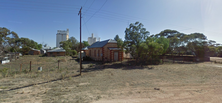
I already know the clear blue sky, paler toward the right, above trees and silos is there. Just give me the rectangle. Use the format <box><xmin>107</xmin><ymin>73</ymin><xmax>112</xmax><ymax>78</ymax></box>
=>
<box><xmin>0</xmin><ymin>0</ymin><xmax>222</xmax><ymax>47</ymax></box>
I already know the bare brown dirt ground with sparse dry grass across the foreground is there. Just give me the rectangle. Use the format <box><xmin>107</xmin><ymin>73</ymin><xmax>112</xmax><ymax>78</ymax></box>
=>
<box><xmin>0</xmin><ymin>56</ymin><xmax>222</xmax><ymax>103</ymax></box>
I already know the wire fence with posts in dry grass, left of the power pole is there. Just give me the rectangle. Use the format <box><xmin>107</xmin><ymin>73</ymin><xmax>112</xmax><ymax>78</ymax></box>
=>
<box><xmin>0</xmin><ymin>57</ymin><xmax>79</xmax><ymax>79</ymax></box>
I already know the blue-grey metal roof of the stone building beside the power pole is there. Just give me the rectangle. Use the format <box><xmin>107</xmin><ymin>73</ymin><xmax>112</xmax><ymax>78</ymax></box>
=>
<box><xmin>88</xmin><ymin>39</ymin><xmax>117</xmax><ymax>48</ymax></box>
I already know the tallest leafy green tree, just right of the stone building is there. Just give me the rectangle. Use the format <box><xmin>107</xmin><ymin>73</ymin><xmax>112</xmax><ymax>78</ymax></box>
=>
<box><xmin>125</xmin><ymin>22</ymin><xmax>150</xmax><ymax>59</ymax></box>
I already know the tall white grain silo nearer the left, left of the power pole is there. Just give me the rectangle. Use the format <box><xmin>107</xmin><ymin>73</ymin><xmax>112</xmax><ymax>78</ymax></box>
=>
<box><xmin>56</xmin><ymin>29</ymin><xmax>69</xmax><ymax>47</ymax></box>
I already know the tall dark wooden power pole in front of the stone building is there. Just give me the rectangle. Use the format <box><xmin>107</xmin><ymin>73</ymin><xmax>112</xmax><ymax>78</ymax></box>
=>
<box><xmin>78</xmin><ymin>7</ymin><xmax>82</xmax><ymax>75</ymax></box>
